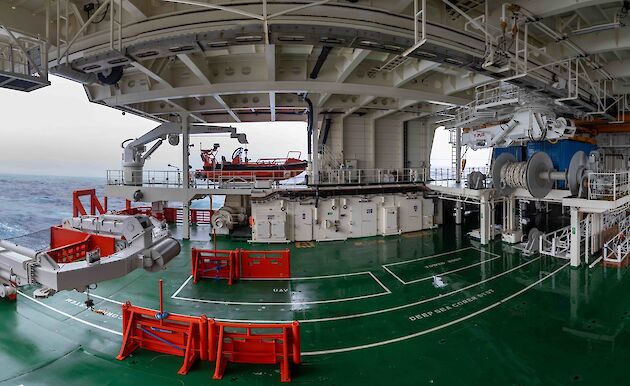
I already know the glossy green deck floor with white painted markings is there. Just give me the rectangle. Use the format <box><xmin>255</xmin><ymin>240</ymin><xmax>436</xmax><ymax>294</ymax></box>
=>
<box><xmin>0</xmin><ymin>226</ymin><xmax>630</xmax><ymax>386</ymax></box>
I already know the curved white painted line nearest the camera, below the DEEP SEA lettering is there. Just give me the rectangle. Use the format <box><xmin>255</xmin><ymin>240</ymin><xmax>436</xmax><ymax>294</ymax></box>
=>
<box><xmin>302</xmin><ymin>263</ymin><xmax>570</xmax><ymax>356</ymax></box>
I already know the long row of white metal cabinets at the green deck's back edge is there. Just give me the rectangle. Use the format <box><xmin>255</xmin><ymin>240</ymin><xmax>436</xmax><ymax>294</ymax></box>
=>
<box><xmin>252</xmin><ymin>193</ymin><xmax>441</xmax><ymax>243</ymax></box>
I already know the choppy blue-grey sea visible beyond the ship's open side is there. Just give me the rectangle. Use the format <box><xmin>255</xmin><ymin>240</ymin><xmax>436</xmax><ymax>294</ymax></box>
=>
<box><xmin>0</xmin><ymin>174</ymin><xmax>223</xmax><ymax>239</ymax></box>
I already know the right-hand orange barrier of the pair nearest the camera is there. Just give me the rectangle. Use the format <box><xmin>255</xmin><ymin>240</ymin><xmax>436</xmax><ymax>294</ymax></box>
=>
<box><xmin>208</xmin><ymin>321</ymin><xmax>301</xmax><ymax>382</ymax></box>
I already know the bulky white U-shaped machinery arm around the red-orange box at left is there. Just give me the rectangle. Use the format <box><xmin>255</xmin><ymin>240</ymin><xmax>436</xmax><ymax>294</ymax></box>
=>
<box><xmin>0</xmin><ymin>214</ymin><xmax>181</xmax><ymax>297</ymax></box>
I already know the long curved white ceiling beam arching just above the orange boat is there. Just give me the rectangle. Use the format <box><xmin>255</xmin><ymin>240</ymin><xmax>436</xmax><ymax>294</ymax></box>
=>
<box><xmin>97</xmin><ymin>81</ymin><xmax>469</xmax><ymax>105</ymax></box>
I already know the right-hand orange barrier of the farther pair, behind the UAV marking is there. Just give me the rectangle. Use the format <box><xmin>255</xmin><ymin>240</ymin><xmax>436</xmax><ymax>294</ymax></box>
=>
<box><xmin>239</xmin><ymin>249</ymin><xmax>291</xmax><ymax>279</ymax></box>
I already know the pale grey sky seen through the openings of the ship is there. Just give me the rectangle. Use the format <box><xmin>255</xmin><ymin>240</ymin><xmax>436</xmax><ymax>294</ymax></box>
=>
<box><xmin>0</xmin><ymin>76</ymin><xmax>488</xmax><ymax>177</ymax></box>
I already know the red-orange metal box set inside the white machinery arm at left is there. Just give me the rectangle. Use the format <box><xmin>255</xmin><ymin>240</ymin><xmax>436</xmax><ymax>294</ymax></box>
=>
<box><xmin>46</xmin><ymin>227</ymin><xmax>116</xmax><ymax>263</ymax></box>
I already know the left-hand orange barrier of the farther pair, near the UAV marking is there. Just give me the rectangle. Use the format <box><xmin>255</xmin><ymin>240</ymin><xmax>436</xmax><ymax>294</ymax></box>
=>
<box><xmin>192</xmin><ymin>248</ymin><xmax>239</xmax><ymax>285</ymax></box>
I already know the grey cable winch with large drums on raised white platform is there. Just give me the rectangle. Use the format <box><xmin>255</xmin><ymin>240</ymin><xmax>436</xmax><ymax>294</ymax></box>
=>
<box><xmin>492</xmin><ymin>151</ymin><xmax>588</xmax><ymax>198</ymax></box>
